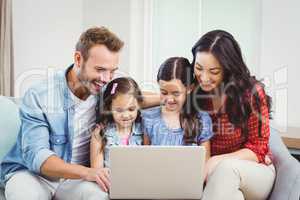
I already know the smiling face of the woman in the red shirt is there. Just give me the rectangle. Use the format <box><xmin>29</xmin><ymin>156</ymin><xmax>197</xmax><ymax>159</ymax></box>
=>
<box><xmin>194</xmin><ymin>52</ymin><xmax>223</xmax><ymax>92</ymax></box>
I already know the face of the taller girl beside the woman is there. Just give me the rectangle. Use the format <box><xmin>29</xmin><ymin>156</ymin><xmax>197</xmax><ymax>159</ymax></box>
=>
<box><xmin>158</xmin><ymin>79</ymin><xmax>187</xmax><ymax>112</ymax></box>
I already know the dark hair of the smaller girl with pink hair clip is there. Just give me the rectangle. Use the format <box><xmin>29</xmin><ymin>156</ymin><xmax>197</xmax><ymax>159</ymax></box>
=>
<box><xmin>96</xmin><ymin>77</ymin><xmax>143</xmax><ymax>150</ymax></box>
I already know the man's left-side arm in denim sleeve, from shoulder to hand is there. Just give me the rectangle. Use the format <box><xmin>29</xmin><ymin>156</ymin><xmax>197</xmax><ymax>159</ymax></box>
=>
<box><xmin>20</xmin><ymin>89</ymin><xmax>109</xmax><ymax>191</ymax></box>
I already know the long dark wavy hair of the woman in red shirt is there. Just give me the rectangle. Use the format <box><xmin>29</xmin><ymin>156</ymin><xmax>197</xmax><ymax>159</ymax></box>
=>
<box><xmin>192</xmin><ymin>30</ymin><xmax>271</xmax><ymax>136</ymax></box>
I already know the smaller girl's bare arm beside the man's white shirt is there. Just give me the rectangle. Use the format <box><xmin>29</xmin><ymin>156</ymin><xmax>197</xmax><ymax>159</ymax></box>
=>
<box><xmin>90</xmin><ymin>127</ymin><xmax>104</xmax><ymax>168</ymax></box>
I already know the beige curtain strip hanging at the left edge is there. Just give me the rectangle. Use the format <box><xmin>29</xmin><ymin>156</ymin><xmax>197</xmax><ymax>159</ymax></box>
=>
<box><xmin>0</xmin><ymin>0</ymin><xmax>14</xmax><ymax>96</ymax></box>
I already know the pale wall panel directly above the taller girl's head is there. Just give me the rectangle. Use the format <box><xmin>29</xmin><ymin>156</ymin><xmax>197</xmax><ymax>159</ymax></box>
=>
<box><xmin>152</xmin><ymin>0</ymin><xmax>201</xmax><ymax>80</ymax></box>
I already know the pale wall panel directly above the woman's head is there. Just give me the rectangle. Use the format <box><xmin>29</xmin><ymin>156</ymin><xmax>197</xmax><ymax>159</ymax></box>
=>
<box><xmin>202</xmin><ymin>0</ymin><xmax>261</xmax><ymax>75</ymax></box>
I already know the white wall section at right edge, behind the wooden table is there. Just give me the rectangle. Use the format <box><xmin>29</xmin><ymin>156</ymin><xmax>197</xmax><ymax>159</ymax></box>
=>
<box><xmin>260</xmin><ymin>0</ymin><xmax>300</xmax><ymax>129</ymax></box>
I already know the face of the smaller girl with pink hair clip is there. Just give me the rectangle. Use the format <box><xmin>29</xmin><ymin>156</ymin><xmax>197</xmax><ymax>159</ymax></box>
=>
<box><xmin>111</xmin><ymin>94</ymin><xmax>139</xmax><ymax>128</ymax></box>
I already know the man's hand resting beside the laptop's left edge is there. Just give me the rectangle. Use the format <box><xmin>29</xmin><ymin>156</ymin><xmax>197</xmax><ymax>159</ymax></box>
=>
<box><xmin>84</xmin><ymin>168</ymin><xmax>110</xmax><ymax>192</ymax></box>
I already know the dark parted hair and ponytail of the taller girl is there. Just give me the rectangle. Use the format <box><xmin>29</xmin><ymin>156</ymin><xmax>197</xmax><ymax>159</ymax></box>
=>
<box><xmin>157</xmin><ymin>57</ymin><xmax>202</xmax><ymax>144</ymax></box>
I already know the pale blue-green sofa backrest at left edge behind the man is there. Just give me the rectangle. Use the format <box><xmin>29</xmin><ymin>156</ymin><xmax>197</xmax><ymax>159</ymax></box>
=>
<box><xmin>0</xmin><ymin>96</ymin><xmax>21</xmax><ymax>162</ymax></box>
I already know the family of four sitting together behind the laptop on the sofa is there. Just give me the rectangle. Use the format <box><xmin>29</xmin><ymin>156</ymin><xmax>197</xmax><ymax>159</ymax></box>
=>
<box><xmin>0</xmin><ymin>27</ymin><xmax>276</xmax><ymax>200</ymax></box>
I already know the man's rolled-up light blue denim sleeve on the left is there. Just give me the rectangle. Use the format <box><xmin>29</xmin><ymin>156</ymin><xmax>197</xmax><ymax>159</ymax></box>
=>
<box><xmin>20</xmin><ymin>90</ymin><xmax>55</xmax><ymax>174</ymax></box>
